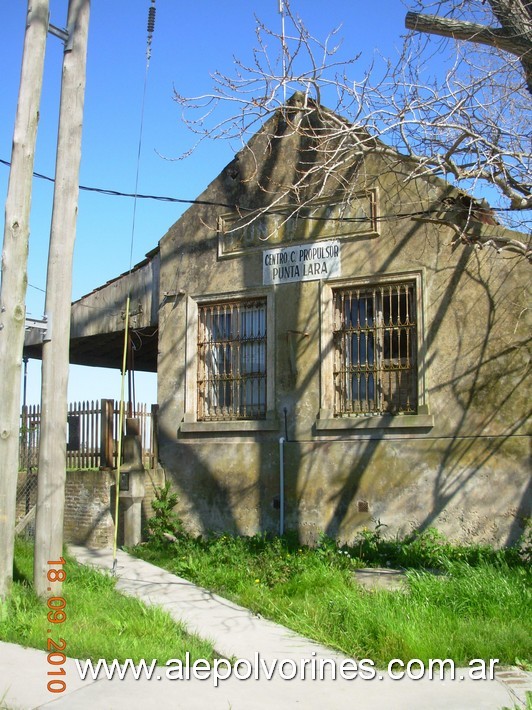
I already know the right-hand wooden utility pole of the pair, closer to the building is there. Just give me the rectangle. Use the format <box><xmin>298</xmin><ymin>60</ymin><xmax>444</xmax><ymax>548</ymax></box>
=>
<box><xmin>34</xmin><ymin>0</ymin><xmax>90</xmax><ymax>597</ymax></box>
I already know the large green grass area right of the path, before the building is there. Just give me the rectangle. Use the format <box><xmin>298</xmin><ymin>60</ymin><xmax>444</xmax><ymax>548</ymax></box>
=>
<box><xmin>130</xmin><ymin>531</ymin><xmax>532</xmax><ymax>667</ymax></box>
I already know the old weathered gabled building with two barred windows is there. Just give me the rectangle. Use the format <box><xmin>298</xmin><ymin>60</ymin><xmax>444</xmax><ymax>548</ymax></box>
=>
<box><xmin>26</xmin><ymin>96</ymin><xmax>531</xmax><ymax>544</ymax></box>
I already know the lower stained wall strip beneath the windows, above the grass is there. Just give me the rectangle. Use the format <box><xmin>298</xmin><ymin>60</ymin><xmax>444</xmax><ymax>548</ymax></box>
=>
<box><xmin>172</xmin><ymin>438</ymin><xmax>531</xmax><ymax>544</ymax></box>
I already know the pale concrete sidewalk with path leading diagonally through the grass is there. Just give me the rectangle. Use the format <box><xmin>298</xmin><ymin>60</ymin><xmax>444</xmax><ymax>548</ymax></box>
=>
<box><xmin>0</xmin><ymin>547</ymin><xmax>532</xmax><ymax>710</ymax></box>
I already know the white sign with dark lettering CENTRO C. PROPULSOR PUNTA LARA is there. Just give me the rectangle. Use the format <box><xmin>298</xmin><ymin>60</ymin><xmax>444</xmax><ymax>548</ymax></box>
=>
<box><xmin>262</xmin><ymin>239</ymin><xmax>341</xmax><ymax>286</ymax></box>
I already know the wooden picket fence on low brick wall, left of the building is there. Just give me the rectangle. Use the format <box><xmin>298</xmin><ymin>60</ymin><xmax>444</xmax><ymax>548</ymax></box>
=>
<box><xmin>19</xmin><ymin>399</ymin><xmax>157</xmax><ymax>470</ymax></box>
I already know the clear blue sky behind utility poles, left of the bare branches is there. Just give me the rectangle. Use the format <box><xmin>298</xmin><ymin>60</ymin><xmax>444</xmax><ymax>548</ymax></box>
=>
<box><xmin>0</xmin><ymin>0</ymin><xmax>407</xmax><ymax>403</ymax></box>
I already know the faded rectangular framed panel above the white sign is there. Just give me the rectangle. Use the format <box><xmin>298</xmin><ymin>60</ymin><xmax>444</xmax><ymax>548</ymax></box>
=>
<box><xmin>218</xmin><ymin>190</ymin><xmax>377</xmax><ymax>257</ymax></box>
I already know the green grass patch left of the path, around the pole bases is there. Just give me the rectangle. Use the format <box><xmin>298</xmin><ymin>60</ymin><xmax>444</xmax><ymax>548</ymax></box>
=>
<box><xmin>0</xmin><ymin>540</ymin><xmax>214</xmax><ymax>663</ymax></box>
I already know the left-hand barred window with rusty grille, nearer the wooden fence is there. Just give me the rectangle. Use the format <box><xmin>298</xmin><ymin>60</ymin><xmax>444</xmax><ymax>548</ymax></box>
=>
<box><xmin>198</xmin><ymin>299</ymin><xmax>266</xmax><ymax>421</ymax></box>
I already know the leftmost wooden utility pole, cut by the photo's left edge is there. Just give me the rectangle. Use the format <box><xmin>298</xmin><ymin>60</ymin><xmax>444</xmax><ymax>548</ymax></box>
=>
<box><xmin>0</xmin><ymin>0</ymin><xmax>49</xmax><ymax>601</ymax></box>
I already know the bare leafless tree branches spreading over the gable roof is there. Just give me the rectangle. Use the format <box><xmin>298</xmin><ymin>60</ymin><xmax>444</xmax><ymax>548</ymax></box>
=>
<box><xmin>175</xmin><ymin>0</ymin><xmax>532</xmax><ymax>259</ymax></box>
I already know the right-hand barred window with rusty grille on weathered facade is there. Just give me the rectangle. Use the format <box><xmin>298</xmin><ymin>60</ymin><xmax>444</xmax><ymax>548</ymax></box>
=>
<box><xmin>333</xmin><ymin>283</ymin><xmax>417</xmax><ymax>416</ymax></box>
